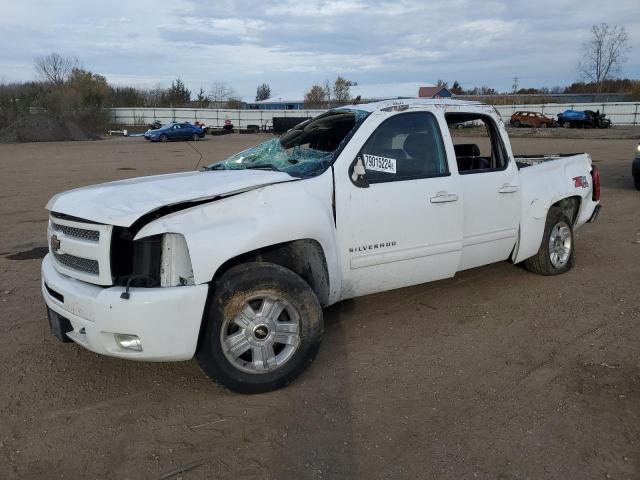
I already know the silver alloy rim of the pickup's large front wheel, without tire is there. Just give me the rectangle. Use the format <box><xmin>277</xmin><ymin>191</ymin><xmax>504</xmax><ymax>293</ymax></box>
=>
<box><xmin>220</xmin><ymin>294</ymin><xmax>300</xmax><ymax>374</ymax></box>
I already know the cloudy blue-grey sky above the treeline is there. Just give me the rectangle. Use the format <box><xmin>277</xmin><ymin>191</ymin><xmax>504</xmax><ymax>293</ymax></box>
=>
<box><xmin>0</xmin><ymin>0</ymin><xmax>640</xmax><ymax>100</ymax></box>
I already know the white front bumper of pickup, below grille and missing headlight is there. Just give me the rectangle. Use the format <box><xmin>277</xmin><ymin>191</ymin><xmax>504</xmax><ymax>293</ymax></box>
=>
<box><xmin>42</xmin><ymin>255</ymin><xmax>209</xmax><ymax>361</ymax></box>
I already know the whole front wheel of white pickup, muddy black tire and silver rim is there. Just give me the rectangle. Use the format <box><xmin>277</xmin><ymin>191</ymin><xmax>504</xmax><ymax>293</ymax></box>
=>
<box><xmin>196</xmin><ymin>262</ymin><xmax>323</xmax><ymax>393</ymax></box>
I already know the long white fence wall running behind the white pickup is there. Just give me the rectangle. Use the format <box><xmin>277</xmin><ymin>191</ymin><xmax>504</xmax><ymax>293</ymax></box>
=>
<box><xmin>110</xmin><ymin>102</ymin><xmax>640</xmax><ymax>128</ymax></box>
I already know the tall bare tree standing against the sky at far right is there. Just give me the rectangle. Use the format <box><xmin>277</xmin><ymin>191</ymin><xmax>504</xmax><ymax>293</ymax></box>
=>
<box><xmin>578</xmin><ymin>23</ymin><xmax>631</xmax><ymax>93</ymax></box>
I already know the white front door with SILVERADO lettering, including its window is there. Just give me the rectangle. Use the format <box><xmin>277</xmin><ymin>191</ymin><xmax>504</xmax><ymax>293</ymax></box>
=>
<box><xmin>335</xmin><ymin>111</ymin><xmax>463</xmax><ymax>298</ymax></box>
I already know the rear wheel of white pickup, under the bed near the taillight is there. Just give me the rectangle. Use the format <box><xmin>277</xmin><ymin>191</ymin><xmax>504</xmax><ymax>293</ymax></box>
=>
<box><xmin>524</xmin><ymin>207</ymin><xmax>575</xmax><ymax>275</ymax></box>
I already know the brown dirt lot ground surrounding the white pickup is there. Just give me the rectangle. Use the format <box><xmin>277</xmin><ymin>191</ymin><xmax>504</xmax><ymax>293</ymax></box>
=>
<box><xmin>0</xmin><ymin>135</ymin><xmax>640</xmax><ymax>480</ymax></box>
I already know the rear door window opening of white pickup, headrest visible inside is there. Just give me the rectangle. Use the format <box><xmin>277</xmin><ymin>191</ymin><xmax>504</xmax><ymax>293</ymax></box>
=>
<box><xmin>445</xmin><ymin>112</ymin><xmax>508</xmax><ymax>175</ymax></box>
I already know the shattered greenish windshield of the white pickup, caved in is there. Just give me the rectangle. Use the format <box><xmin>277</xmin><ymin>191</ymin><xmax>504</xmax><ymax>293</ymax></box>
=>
<box><xmin>205</xmin><ymin>108</ymin><xmax>368</xmax><ymax>177</ymax></box>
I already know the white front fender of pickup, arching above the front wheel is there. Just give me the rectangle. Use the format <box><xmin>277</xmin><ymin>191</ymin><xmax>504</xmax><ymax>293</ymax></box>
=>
<box><xmin>135</xmin><ymin>171</ymin><xmax>341</xmax><ymax>299</ymax></box>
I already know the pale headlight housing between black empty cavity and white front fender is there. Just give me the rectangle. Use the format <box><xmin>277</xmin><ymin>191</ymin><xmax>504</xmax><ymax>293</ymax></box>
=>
<box><xmin>160</xmin><ymin>233</ymin><xmax>195</xmax><ymax>287</ymax></box>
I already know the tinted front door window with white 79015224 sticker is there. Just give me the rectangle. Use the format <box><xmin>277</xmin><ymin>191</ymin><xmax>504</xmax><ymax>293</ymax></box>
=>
<box><xmin>357</xmin><ymin>112</ymin><xmax>449</xmax><ymax>184</ymax></box>
